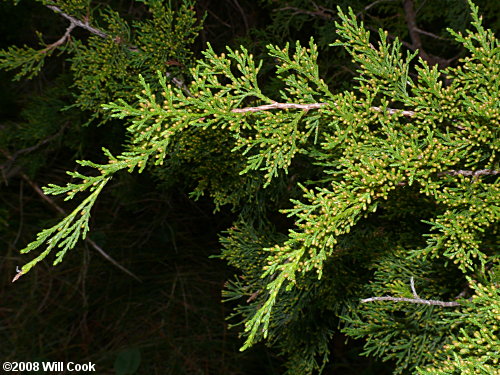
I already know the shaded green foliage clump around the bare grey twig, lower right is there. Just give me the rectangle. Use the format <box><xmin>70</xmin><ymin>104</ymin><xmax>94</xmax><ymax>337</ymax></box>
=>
<box><xmin>342</xmin><ymin>248</ymin><xmax>467</xmax><ymax>374</ymax></box>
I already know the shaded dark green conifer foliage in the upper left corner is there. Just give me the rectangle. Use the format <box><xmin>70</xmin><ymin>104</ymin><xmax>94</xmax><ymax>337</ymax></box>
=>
<box><xmin>0</xmin><ymin>0</ymin><xmax>201</xmax><ymax>120</ymax></box>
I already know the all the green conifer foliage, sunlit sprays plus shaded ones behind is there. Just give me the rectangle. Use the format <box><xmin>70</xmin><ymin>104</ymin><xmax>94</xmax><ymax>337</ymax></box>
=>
<box><xmin>0</xmin><ymin>1</ymin><xmax>500</xmax><ymax>374</ymax></box>
